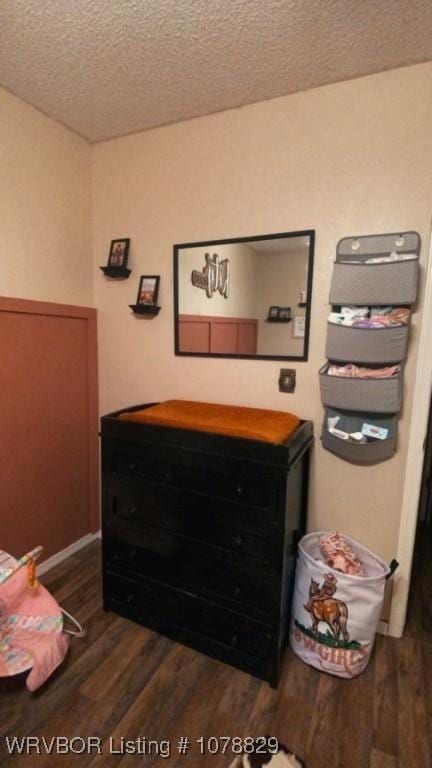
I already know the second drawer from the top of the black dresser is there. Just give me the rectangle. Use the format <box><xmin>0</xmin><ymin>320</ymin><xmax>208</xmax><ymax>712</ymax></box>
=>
<box><xmin>104</xmin><ymin>482</ymin><xmax>280</xmax><ymax>563</ymax></box>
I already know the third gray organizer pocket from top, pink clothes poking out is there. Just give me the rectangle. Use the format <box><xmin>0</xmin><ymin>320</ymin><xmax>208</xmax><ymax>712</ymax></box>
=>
<box><xmin>319</xmin><ymin>364</ymin><xmax>402</xmax><ymax>413</ymax></box>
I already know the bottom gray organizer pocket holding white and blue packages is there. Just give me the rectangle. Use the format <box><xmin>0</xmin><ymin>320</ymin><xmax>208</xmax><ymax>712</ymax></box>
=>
<box><xmin>321</xmin><ymin>408</ymin><xmax>396</xmax><ymax>464</ymax></box>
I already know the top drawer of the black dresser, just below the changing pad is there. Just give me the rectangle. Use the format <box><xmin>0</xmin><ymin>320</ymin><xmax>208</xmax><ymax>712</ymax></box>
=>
<box><xmin>104</xmin><ymin>442</ymin><xmax>274</xmax><ymax>509</ymax></box>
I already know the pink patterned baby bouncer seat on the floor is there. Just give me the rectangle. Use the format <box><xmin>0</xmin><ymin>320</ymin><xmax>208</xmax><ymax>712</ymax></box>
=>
<box><xmin>0</xmin><ymin>547</ymin><xmax>84</xmax><ymax>691</ymax></box>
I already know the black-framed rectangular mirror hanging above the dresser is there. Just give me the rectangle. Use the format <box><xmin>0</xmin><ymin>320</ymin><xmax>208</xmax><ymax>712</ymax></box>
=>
<box><xmin>174</xmin><ymin>229</ymin><xmax>315</xmax><ymax>360</ymax></box>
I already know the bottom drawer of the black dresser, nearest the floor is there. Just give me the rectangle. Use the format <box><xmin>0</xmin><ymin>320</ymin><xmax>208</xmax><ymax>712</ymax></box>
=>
<box><xmin>104</xmin><ymin>570</ymin><xmax>272</xmax><ymax>660</ymax></box>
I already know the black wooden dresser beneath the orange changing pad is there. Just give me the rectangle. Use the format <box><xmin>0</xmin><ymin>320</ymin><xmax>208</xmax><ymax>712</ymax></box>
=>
<box><xmin>101</xmin><ymin>403</ymin><xmax>313</xmax><ymax>687</ymax></box>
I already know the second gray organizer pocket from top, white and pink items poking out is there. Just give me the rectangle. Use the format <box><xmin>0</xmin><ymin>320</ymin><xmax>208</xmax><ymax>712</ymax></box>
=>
<box><xmin>325</xmin><ymin>323</ymin><xmax>408</xmax><ymax>364</ymax></box>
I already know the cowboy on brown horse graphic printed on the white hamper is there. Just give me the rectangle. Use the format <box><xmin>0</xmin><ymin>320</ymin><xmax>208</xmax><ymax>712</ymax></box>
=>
<box><xmin>303</xmin><ymin>573</ymin><xmax>349</xmax><ymax>643</ymax></box>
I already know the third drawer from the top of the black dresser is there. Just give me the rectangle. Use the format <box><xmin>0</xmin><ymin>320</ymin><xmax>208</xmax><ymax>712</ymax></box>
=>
<box><xmin>103</xmin><ymin>535</ymin><xmax>281</xmax><ymax>621</ymax></box>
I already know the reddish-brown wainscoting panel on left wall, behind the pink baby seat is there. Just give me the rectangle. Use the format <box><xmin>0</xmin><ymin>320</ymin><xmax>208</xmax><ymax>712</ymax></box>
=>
<box><xmin>0</xmin><ymin>297</ymin><xmax>99</xmax><ymax>559</ymax></box>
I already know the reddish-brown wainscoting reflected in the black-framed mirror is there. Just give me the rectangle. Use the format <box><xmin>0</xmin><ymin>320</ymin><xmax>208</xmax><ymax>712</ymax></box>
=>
<box><xmin>179</xmin><ymin>315</ymin><xmax>258</xmax><ymax>355</ymax></box>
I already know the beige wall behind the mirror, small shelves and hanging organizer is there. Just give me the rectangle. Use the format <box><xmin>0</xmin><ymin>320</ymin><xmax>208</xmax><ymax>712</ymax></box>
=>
<box><xmin>93</xmin><ymin>64</ymin><xmax>432</xmax><ymax>558</ymax></box>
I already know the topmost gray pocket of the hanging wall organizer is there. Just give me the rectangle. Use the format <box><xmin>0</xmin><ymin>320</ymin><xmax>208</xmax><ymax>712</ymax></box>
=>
<box><xmin>330</xmin><ymin>258</ymin><xmax>418</xmax><ymax>306</ymax></box>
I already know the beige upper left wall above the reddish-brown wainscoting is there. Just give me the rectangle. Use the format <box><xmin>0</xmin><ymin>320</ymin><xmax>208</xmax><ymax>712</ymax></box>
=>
<box><xmin>0</xmin><ymin>89</ymin><xmax>92</xmax><ymax>305</ymax></box>
